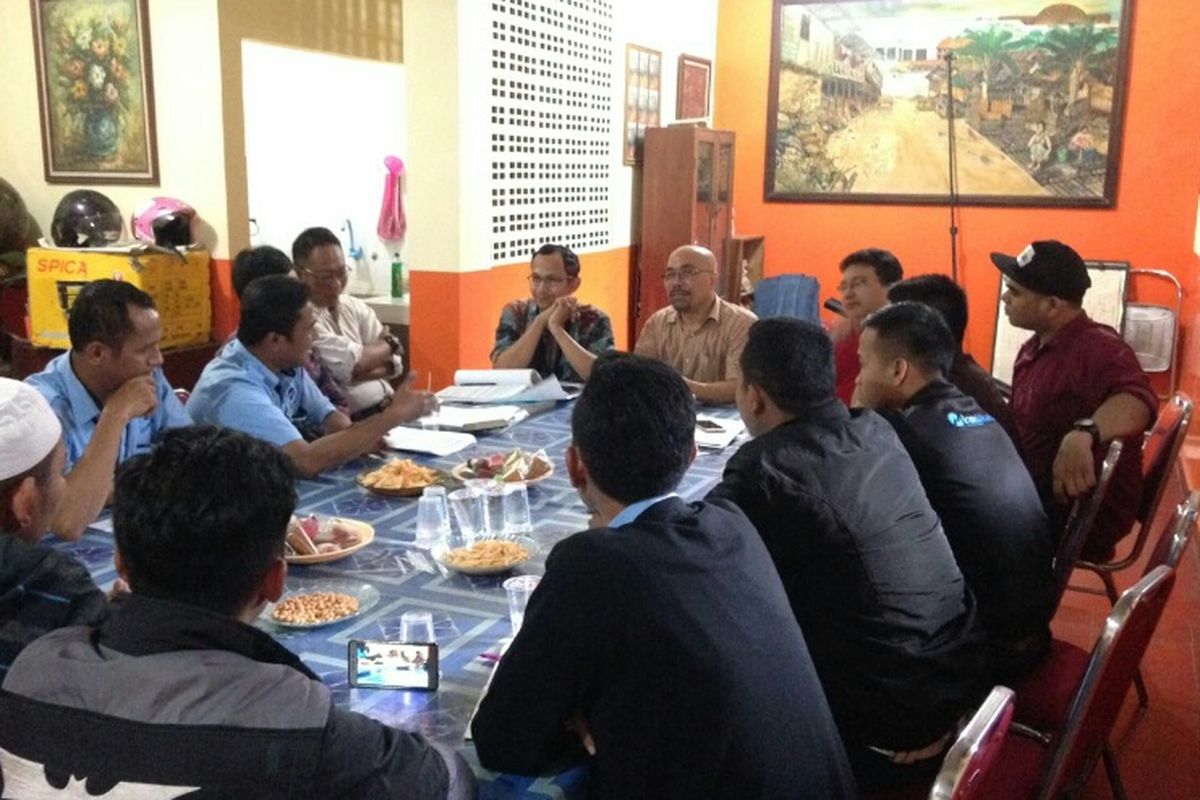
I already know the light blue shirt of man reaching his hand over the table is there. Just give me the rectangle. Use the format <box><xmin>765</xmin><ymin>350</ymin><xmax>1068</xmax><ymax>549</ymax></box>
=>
<box><xmin>187</xmin><ymin>339</ymin><xmax>336</xmax><ymax>447</ymax></box>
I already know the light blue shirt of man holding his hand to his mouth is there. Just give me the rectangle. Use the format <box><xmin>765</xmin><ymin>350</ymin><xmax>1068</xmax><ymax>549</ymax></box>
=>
<box><xmin>25</xmin><ymin>350</ymin><xmax>192</xmax><ymax>470</ymax></box>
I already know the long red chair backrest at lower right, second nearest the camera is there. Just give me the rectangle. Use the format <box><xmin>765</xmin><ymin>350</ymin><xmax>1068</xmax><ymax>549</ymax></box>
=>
<box><xmin>1038</xmin><ymin>566</ymin><xmax>1175</xmax><ymax>800</ymax></box>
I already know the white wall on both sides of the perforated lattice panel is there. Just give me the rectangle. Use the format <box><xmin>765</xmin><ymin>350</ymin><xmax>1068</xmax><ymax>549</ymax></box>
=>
<box><xmin>404</xmin><ymin>0</ymin><xmax>716</xmax><ymax>272</ymax></box>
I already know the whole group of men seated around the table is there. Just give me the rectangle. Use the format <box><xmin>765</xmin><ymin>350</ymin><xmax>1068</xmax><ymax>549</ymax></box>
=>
<box><xmin>0</xmin><ymin>229</ymin><xmax>1157</xmax><ymax>798</ymax></box>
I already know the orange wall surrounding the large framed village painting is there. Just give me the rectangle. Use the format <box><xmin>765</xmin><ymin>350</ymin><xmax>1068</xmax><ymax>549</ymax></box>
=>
<box><xmin>714</xmin><ymin>0</ymin><xmax>1200</xmax><ymax>389</ymax></box>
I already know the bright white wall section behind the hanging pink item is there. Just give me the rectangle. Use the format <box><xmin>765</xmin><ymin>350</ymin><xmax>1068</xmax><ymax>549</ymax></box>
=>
<box><xmin>241</xmin><ymin>41</ymin><xmax>406</xmax><ymax>294</ymax></box>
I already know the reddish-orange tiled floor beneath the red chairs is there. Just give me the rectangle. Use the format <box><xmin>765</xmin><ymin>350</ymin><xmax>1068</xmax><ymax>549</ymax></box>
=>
<box><xmin>1054</xmin><ymin>472</ymin><xmax>1200</xmax><ymax>800</ymax></box>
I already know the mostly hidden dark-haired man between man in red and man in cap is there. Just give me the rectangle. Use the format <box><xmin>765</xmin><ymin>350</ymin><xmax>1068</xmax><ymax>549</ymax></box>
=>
<box><xmin>888</xmin><ymin>275</ymin><xmax>1018</xmax><ymax>443</ymax></box>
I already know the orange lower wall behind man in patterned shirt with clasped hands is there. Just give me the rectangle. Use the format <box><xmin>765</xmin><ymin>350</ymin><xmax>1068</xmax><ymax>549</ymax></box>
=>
<box><xmin>409</xmin><ymin>247</ymin><xmax>631</xmax><ymax>387</ymax></box>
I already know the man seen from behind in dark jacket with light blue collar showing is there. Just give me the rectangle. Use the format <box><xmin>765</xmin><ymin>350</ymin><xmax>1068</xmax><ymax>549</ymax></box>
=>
<box><xmin>473</xmin><ymin>355</ymin><xmax>856</xmax><ymax>800</ymax></box>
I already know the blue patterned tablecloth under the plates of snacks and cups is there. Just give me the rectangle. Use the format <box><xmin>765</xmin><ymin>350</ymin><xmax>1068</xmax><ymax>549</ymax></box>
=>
<box><xmin>61</xmin><ymin>403</ymin><xmax>745</xmax><ymax>798</ymax></box>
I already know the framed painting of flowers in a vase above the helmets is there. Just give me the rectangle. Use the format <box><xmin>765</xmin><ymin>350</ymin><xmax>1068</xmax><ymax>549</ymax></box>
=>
<box><xmin>30</xmin><ymin>0</ymin><xmax>158</xmax><ymax>185</ymax></box>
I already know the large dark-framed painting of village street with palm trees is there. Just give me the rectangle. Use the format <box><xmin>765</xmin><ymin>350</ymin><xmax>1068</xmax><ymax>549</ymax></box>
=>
<box><xmin>764</xmin><ymin>0</ymin><xmax>1134</xmax><ymax>207</ymax></box>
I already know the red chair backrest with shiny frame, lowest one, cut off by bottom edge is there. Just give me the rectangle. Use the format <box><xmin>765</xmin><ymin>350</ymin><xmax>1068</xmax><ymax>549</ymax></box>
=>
<box><xmin>929</xmin><ymin>686</ymin><xmax>1013</xmax><ymax>800</ymax></box>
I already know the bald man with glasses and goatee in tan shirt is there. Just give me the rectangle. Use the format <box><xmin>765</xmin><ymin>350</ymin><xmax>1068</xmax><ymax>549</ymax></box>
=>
<box><xmin>634</xmin><ymin>245</ymin><xmax>757</xmax><ymax>403</ymax></box>
